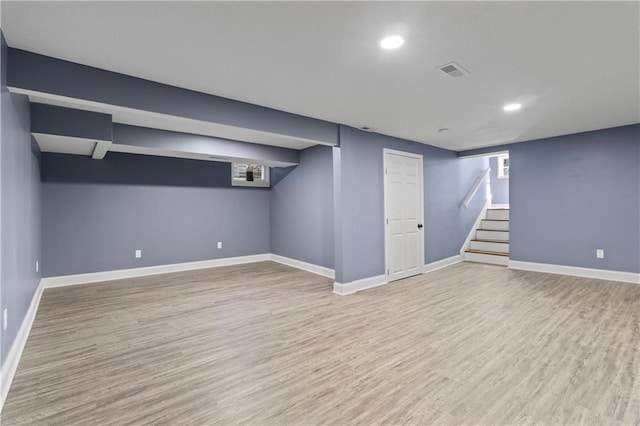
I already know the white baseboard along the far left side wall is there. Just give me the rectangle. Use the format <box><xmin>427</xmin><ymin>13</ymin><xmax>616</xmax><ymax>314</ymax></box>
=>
<box><xmin>0</xmin><ymin>280</ymin><xmax>44</xmax><ymax>412</ymax></box>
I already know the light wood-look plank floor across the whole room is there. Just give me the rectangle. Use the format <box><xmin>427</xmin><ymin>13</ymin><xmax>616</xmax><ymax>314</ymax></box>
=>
<box><xmin>2</xmin><ymin>262</ymin><xmax>640</xmax><ymax>425</ymax></box>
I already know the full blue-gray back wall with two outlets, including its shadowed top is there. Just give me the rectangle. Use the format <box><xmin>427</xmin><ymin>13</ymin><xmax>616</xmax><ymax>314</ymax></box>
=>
<box><xmin>42</xmin><ymin>153</ymin><xmax>270</xmax><ymax>277</ymax></box>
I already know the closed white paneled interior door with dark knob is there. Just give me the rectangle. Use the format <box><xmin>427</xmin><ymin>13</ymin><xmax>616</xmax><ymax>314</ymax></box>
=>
<box><xmin>384</xmin><ymin>149</ymin><xmax>424</xmax><ymax>281</ymax></box>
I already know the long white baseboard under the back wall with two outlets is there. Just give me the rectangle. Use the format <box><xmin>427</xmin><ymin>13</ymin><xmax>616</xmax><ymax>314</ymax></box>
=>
<box><xmin>42</xmin><ymin>253</ymin><xmax>271</xmax><ymax>288</ymax></box>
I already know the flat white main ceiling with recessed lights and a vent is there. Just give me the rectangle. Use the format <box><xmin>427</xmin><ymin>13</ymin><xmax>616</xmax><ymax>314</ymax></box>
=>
<box><xmin>2</xmin><ymin>1</ymin><xmax>640</xmax><ymax>150</ymax></box>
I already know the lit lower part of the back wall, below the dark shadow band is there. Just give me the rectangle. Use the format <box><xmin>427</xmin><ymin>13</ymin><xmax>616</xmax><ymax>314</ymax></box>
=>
<box><xmin>43</xmin><ymin>182</ymin><xmax>270</xmax><ymax>277</ymax></box>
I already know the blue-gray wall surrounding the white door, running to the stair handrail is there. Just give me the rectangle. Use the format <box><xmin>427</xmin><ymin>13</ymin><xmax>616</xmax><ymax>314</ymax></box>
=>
<box><xmin>334</xmin><ymin>126</ymin><xmax>488</xmax><ymax>283</ymax></box>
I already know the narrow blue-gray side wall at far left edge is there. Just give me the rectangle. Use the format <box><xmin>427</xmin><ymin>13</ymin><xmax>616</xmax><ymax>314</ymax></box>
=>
<box><xmin>0</xmin><ymin>33</ymin><xmax>41</xmax><ymax>364</ymax></box>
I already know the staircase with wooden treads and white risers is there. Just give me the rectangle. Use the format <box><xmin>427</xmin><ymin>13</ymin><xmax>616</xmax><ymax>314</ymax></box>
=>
<box><xmin>464</xmin><ymin>208</ymin><xmax>509</xmax><ymax>266</ymax></box>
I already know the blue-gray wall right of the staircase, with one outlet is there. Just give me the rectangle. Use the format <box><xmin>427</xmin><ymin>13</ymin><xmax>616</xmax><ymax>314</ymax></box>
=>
<box><xmin>508</xmin><ymin>125</ymin><xmax>640</xmax><ymax>272</ymax></box>
